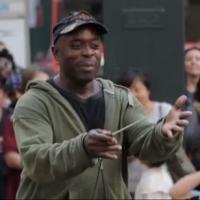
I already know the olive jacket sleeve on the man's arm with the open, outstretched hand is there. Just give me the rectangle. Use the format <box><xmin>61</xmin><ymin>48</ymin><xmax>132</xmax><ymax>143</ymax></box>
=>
<box><xmin>124</xmin><ymin>91</ymin><xmax>182</xmax><ymax>162</ymax></box>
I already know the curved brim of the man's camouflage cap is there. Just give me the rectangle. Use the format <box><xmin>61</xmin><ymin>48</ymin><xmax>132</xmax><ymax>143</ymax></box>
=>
<box><xmin>59</xmin><ymin>22</ymin><xmax>108</xmax><ymax>35</ymax></box>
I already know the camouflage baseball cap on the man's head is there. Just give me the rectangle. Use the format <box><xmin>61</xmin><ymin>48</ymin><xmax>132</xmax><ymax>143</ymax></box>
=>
<box><xmin>53</xmin><ymin>10</ymin><xmax>108</xmax><ymax>44</ymax></box>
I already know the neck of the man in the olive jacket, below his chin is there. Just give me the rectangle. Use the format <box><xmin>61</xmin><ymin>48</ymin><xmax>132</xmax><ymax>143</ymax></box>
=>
<box><xmin>54</xmin><ymin>75</ymin><xmax>101</xmax><ymax>99</ymax></box>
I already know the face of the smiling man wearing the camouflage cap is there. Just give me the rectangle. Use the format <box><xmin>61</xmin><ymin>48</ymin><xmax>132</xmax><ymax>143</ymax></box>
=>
<box><xmin>53</xmin><ymin>27</ymin><xmax>103</xmax><ymax>83</ymax></box>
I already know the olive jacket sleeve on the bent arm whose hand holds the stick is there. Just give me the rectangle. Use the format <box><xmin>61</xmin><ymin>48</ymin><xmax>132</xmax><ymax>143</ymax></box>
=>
<box><xmin>14</xmin><ymin>94</ymin><xmax>94</xmax><ymax>183</ymax></box>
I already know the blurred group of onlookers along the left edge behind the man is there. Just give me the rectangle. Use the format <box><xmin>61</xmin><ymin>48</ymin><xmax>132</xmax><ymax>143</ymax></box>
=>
<box><xmin>0</xmin><ymin>42</ymin><xmax>54</xmax><ymax>199</ymax></box>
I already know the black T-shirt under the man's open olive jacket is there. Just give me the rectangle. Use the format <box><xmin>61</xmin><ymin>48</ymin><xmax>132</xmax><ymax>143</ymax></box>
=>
<box><xmin>47</xmin><ymin>79</ymin><xmax>105</xmax><ymax>130</ymax></box>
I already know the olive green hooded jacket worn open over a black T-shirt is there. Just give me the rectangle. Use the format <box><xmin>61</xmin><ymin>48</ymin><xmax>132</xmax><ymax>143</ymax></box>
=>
<box><xmin>14</xmin><ymin>79</ymin><xmax>182</xmax><ymax>199</ymax></box>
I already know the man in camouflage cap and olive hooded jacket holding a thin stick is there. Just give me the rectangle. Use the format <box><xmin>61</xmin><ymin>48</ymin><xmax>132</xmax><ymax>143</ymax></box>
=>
<box><xmin>14</xmin><ymin>11</ymin><xmax>191</xmax><ymax>199</ymax></box>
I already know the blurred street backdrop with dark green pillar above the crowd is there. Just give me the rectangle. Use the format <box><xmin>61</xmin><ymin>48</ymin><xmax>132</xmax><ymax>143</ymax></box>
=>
<box><xmin>0</xmin><ymin>0</ymin><xmax>200</xmax><ymax>102</ymax></box>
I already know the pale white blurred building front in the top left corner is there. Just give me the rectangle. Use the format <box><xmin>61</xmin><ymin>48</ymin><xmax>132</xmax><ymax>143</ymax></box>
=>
<box><xmin>0</xmin><ymin>0</ymin><xmax>30</xmax><ymax>68</ymax></box>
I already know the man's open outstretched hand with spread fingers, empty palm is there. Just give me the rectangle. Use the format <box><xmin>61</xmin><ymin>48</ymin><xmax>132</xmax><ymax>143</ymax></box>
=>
<box><xmin>162</xmin><ymin>95</ymin><xmax>192</xmax><ymax>138</ymax></box>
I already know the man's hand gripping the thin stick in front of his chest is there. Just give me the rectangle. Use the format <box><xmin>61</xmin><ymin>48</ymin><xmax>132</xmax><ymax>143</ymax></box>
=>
<box><xmin>84</xmin><ymin>129</ymin><xmax>122</xmax><ymax>160</ymax></box>
